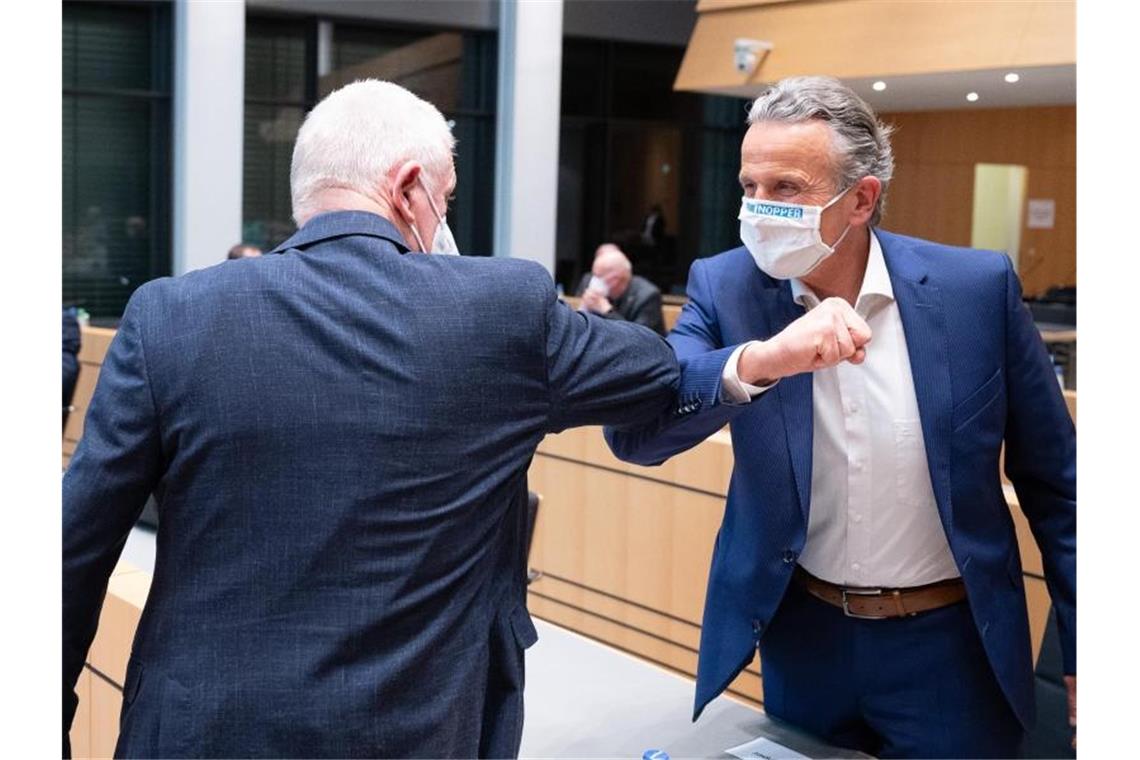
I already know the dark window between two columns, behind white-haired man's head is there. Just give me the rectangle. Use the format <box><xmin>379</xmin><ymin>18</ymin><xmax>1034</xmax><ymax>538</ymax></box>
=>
<box><xmin>243</xmin><ymin>16</ymin><xmax>497</xmax><ymax>254</ymax></box>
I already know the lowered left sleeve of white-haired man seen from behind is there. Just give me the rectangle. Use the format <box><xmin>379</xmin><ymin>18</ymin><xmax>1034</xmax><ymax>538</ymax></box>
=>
<box><xmin>63</xmin><ymin>286</ymin><xmax>161</xmax><ymax>753</ymax></box>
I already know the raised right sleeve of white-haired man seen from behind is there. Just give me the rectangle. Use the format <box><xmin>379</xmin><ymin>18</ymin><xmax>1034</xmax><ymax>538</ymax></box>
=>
<box><xmin>543</xmin><ymin>272</ymin><xmax>678</xmax><ymax>432</ymax></box>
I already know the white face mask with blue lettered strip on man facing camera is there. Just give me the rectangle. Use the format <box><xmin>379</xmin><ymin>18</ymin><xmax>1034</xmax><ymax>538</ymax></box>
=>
<box><xmin>739</xmin><ymin>188</ymin><xmax>850</xmax><ymax>279</ymax></box>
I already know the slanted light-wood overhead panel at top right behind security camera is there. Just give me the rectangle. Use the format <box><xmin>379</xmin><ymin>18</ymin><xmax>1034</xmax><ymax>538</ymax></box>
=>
<box><xmin>674</xmin><ymin>0</ymin><xmax>1076</xmax><ymax>91</ymax></box>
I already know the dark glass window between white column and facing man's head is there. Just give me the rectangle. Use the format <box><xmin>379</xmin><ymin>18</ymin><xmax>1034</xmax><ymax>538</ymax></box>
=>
<box><xmin>555</xmin><ymin>39</ymin><xmax>744</xmax><ymax>293</ymax></box>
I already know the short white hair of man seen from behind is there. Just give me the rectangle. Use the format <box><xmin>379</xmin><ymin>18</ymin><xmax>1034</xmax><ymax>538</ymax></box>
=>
<box><xmin>290</xmin><ymin>79</ymin><xmax>455</xmax><ymax>224</ymax></box>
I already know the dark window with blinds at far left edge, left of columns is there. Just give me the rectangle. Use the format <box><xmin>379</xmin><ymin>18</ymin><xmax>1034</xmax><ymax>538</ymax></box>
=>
<box><xmin>63</xmin><ymin>2</ymin><xmax>172</xmax><ymax>321</ymax></box>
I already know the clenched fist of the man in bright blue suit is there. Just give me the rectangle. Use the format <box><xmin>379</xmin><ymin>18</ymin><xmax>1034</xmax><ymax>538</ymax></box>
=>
<box><xmin>738</xmin><ymin>299</ymin><xmax>871</xmax><ymax>385</ymax></box>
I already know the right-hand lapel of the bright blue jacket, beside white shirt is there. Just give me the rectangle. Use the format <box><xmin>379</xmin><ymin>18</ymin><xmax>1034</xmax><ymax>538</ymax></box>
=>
<box><xmin>871</xmin><ymin>231</ymin><xmax>953</xmax><ymax>534</ymax></box>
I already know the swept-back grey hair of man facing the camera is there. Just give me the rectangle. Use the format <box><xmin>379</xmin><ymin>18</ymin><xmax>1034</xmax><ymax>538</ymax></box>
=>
<box><xmin>748</xmin><ymin>76</ymin><xmax>895</xmax><ymax>226</ymax></box>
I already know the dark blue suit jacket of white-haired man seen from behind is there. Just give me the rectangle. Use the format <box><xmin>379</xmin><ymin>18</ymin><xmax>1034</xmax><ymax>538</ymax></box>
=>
<box><xmin>63</xmin><ymin>212</ymin><xmax>678</xmax><ymax>758</ymax></box>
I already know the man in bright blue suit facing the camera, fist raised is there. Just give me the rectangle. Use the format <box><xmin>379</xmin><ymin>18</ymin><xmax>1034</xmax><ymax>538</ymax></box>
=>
<box><xmin>606</xmin><ymin>77</ymin><xmax>1076</xmax><ymax>758</ymax></box>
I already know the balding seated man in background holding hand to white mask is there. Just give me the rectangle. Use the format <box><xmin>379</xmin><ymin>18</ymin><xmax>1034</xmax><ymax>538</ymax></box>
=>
<box><xmin>578</xmin><ymin>243</ymin><xmax>665</xmax><ymax>335</ymax></box>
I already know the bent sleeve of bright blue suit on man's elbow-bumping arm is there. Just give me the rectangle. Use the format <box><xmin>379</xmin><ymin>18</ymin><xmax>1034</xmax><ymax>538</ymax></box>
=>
<box><xmin>605</xmin><ymin>260</ymin><xmax>768</xmax><ymax>465</ymax></box>
